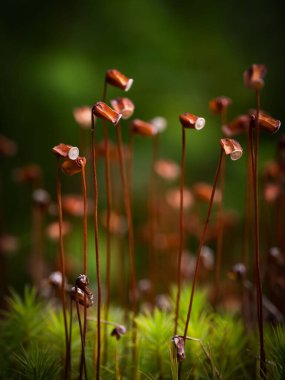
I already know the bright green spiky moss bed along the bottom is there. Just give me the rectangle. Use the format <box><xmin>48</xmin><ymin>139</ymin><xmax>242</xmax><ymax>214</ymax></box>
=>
<box><xmin>0</xmin><ymin>288</ymin><xmax>285</xmax><ymax>380</ymax></box>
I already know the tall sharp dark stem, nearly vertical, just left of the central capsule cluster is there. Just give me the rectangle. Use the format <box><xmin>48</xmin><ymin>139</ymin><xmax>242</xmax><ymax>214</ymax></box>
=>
<box><xmin>91</xmin><ymin>110</ymin><xmax>101</xmax><ymax>380</ymax></box>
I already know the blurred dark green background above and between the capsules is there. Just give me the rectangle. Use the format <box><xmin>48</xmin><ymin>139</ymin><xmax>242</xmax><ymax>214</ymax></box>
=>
<box><xmin>0</xmin><ymin>0</ymin><xmax>285</xmax><ymax>287</ymax></box>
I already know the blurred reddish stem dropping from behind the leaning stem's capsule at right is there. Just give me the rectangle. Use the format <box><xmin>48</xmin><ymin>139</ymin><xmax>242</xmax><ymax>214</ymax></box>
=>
<box><xmin>215</xmin><ymin>156</ymin><xmax>226</xmax><ymax>305</ymax></box>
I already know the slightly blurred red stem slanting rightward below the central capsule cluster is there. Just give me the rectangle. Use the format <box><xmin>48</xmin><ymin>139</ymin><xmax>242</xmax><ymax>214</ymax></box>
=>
<box><xmin>116</xmin><ymin>124</ymin><xmax>137</xmax><ymax>360</ymax></box>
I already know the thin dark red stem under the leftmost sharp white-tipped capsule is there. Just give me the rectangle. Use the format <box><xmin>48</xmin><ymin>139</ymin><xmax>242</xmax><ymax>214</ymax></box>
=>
<box><xmin>57</xmin><ymin>157</ymin><xmax>69</xmax><ymax>379</ymax></box>
